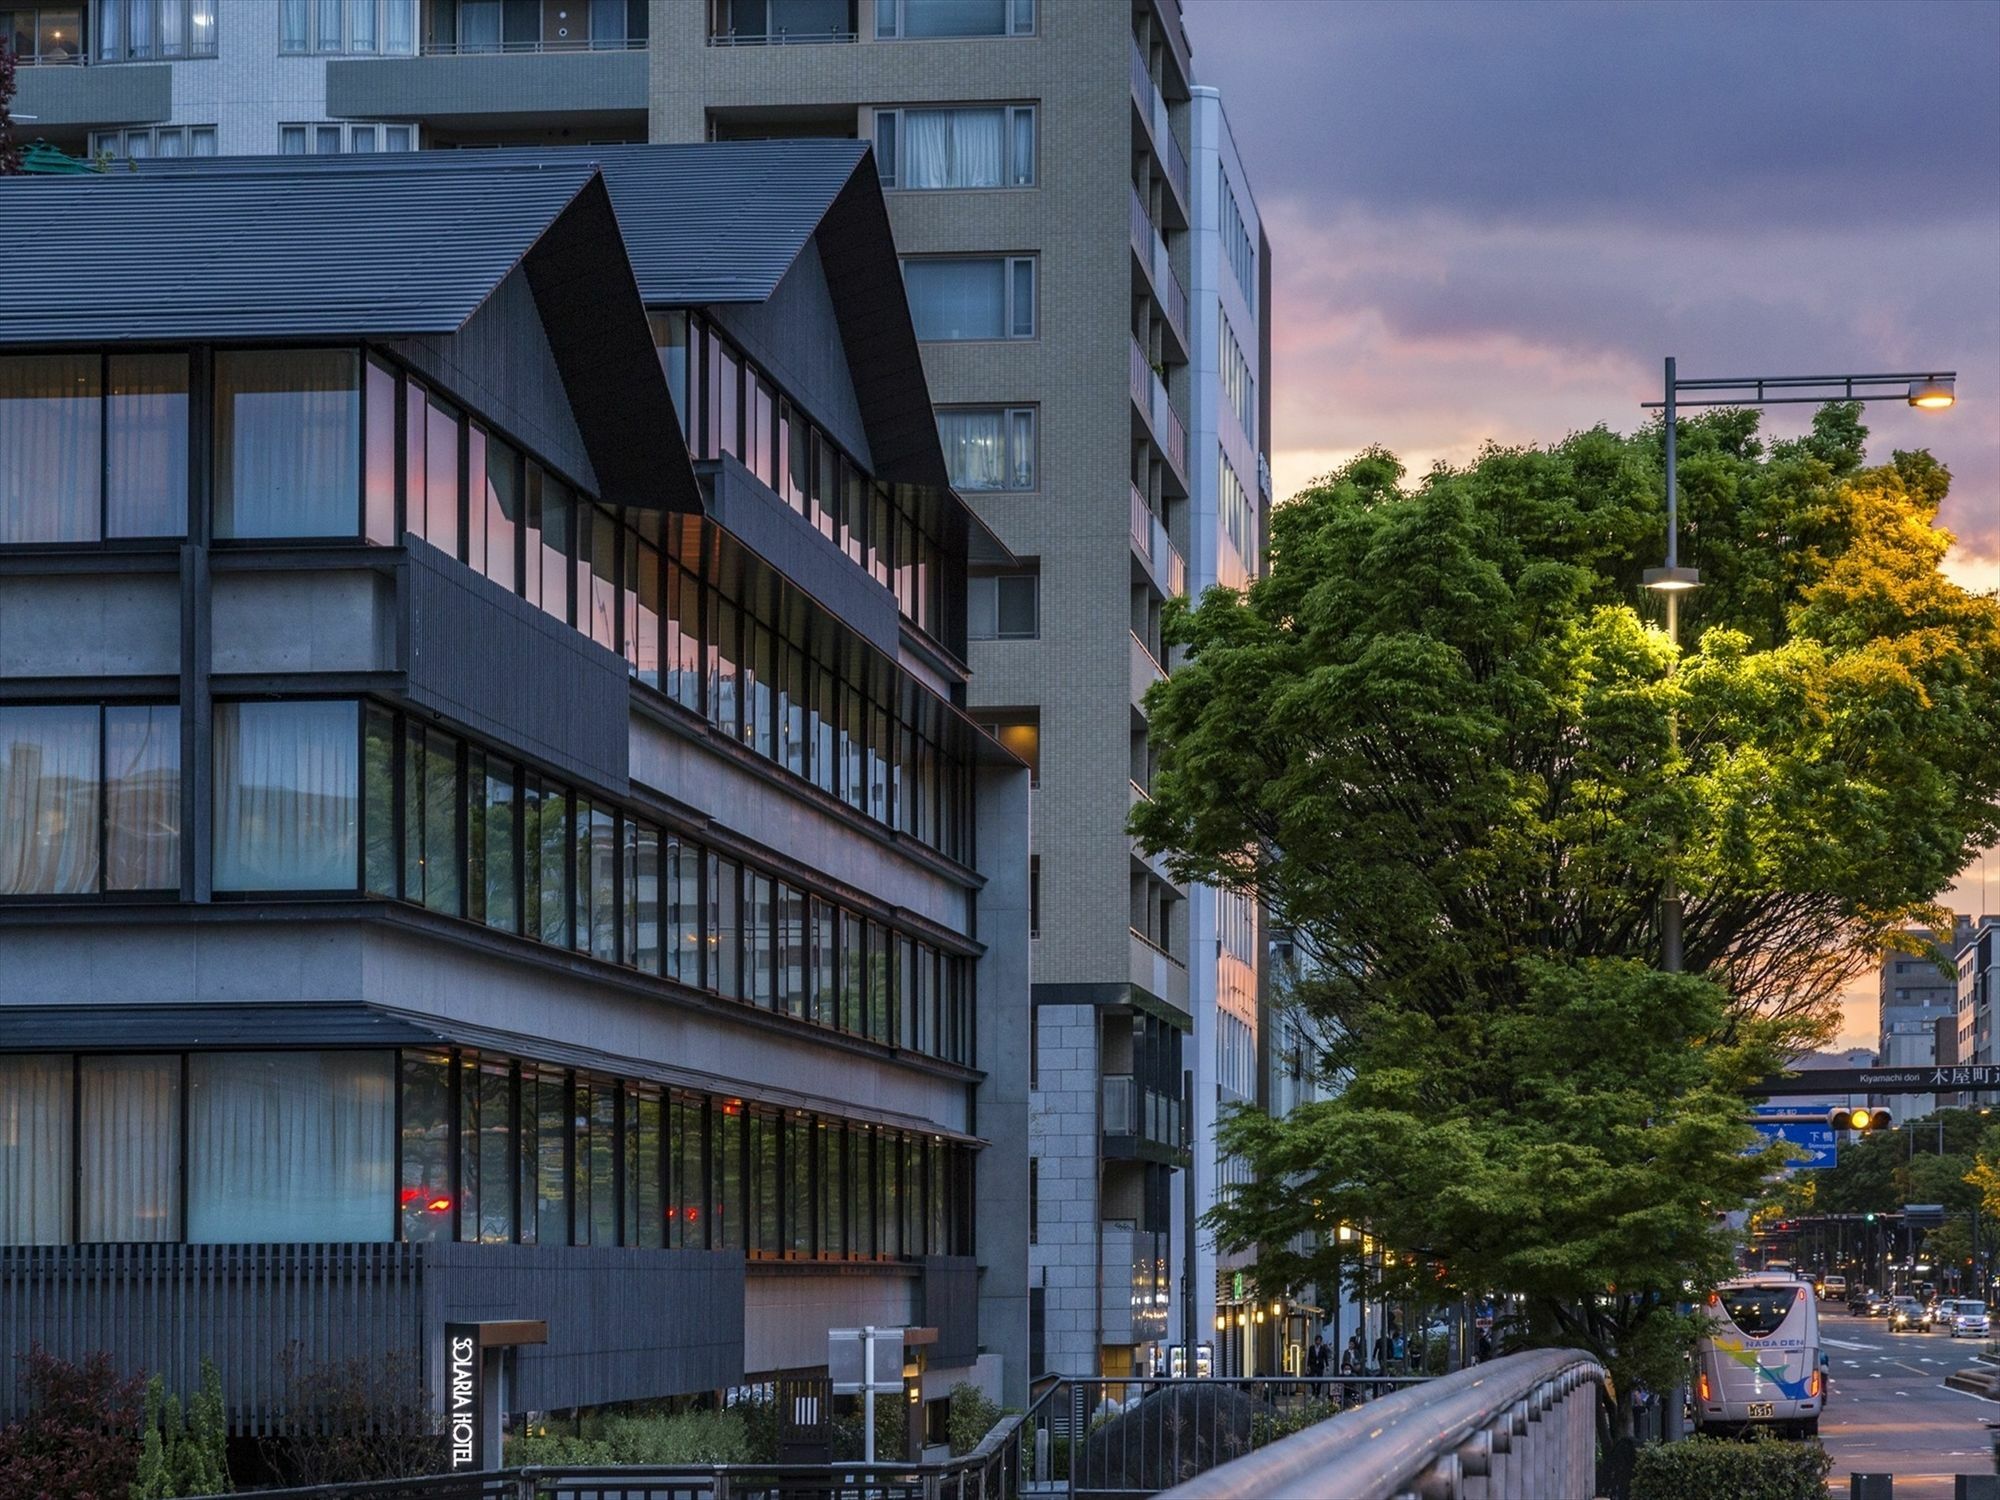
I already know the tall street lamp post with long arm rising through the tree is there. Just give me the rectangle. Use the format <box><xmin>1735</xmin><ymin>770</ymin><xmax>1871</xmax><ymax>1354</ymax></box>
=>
<box><xmin>1640</xmin><ymin>354</ymin><xmax>1958</xmax><ymax>1440</ymax></box>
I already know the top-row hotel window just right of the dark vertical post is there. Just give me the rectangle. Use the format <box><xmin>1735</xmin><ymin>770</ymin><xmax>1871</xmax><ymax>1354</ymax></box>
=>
<box><xmin>216</xmin><ymin>348</ymin><xmax>362</xmax><ymax>536</ymax></box>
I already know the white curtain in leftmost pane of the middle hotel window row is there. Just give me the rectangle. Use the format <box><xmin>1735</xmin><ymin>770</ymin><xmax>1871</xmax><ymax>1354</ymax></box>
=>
<box><xmin>0</xmin><ymin>704</ymin><xmax>98</xmax><ymax>896</ymax></box>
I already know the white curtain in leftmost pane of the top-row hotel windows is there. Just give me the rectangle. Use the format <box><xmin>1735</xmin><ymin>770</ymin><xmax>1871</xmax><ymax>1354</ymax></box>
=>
<box><xmin>0</xmin><ymin>354</ymin><xmax>100</xmax><ymax>542</ymax></box>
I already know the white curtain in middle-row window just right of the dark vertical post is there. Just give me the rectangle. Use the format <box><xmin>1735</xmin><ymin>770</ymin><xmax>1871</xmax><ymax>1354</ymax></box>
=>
<box><xmin>214</xmin><ymin>702</ymin><xmax>360</xmax><ymax>890</ymax></box>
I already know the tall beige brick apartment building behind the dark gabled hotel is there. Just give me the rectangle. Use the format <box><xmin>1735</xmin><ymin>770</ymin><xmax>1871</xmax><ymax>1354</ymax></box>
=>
<box><xmin>650</xmin><ymin>0</ymin><xmax>1276</xmax><ymax>1374</ymax></box>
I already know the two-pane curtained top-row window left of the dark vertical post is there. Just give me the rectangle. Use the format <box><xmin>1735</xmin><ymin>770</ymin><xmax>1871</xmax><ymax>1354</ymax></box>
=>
<box><xmin>0</xmin><ymin>354</ymin><xmax>188</xmax><ymax>542</ymax></box>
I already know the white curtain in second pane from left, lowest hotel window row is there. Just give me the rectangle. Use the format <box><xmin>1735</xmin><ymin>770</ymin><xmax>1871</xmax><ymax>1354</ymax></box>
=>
<box><xmin>76</xmin><ymin>1056</ymin><xmax>180</xmax><ymax>1244</ymax></box>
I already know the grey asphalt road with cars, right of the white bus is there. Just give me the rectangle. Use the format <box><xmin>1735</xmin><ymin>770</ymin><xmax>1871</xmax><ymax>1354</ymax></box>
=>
<box><xmin>1820</xmin><ymin>1302</ymin><xmax>2000</xmax><ymax>1500</ymax></box>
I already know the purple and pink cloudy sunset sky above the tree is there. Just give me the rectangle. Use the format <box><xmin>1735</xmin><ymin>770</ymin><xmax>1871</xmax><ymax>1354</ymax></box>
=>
<box><xmin>1184</xmin><ymin>0</ymin><xmax>2000</xmax><ymax>1040</ymax></box>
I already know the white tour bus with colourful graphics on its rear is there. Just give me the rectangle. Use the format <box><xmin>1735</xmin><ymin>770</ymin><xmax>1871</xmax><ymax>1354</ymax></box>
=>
<box><xmin>1694</xmin><ymin>1270</ymin><xmax>1826</xmax><ymax>1438</ymax></box>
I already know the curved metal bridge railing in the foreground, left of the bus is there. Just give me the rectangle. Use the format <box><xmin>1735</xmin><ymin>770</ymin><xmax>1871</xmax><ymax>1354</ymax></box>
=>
<box><xmin>1160</xmin><ymin>1350</ymin><xmax>1604</xmax><ymax>1500</ymax></box>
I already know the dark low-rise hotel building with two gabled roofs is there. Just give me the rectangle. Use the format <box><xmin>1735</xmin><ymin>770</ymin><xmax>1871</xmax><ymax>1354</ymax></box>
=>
<box><xmin>0</xmin><ymin>142</ymin><xmax>1028</xmax><ymax>1430</ymax></box>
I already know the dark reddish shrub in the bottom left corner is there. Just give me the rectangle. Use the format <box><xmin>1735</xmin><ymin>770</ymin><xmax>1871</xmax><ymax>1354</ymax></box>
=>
<box><xmin>0</xmin><ymin>1344</ymin><xmax>140</xmax><ymax>1500</ymax></box>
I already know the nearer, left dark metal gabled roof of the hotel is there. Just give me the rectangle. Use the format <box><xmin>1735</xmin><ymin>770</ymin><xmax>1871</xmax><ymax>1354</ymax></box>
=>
<box><xmin>0</xmin><ymin>152</ymin><xmax>702</xmax><ymax>512</ymax></box>
